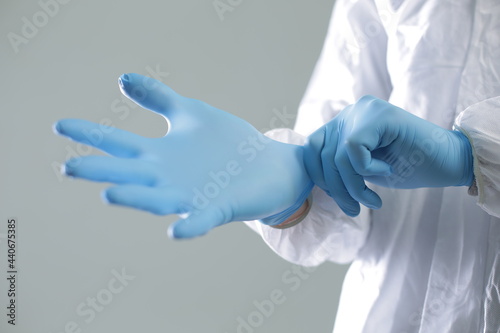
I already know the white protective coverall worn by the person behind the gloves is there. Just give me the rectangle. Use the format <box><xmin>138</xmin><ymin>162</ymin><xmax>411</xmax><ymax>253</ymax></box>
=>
<box><xmin>246</xmin><ymin>0</ymin><xmax>500</xmax><ymax>333</ymax></box>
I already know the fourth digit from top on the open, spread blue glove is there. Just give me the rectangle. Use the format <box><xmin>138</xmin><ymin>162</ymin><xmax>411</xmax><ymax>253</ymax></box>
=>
<box><xmin>102</xmin><ymin>185</ymin><xmax>189</xmax><ymax>215</ymax></box>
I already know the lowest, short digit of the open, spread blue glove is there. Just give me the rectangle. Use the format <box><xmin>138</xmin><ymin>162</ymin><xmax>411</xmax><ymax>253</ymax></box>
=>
<box><xmin>168</xmin><ymin>206</ymin><xmax>229</xmax><ymax>239</ymax></box>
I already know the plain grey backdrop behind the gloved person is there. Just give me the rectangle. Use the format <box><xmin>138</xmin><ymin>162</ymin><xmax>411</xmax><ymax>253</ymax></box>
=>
<box><xmin>0</xmin><ymin>0</ymin><xmax>346</xmax><ymax>333</ymax></box>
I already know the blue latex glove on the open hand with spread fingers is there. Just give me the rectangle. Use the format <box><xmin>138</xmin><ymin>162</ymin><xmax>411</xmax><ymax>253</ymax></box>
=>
<box><xmin>54</xmin><ymin>74</ymin><xmax>313</xmax><ymax>238</ymax></box>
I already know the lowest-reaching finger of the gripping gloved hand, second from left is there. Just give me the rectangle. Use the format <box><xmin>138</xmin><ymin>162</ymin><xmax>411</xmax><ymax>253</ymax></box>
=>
<box><xmin>321</xmin><ymin>131</ymin><xmax>360</xmax><ymax>216</ymax></box>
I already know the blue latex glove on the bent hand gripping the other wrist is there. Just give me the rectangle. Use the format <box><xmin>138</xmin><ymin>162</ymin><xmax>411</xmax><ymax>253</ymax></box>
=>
<box><xmin>304</xmin><ymin>96</ymin><xmax>474</xmax><ymax>216</ymax></box>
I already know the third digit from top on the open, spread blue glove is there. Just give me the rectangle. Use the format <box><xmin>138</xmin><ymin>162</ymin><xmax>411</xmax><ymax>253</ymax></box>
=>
<box><xmin>63</xmin><ymin>156</ymin><xmax>160</xmax><ymax>186</ymax></box>
